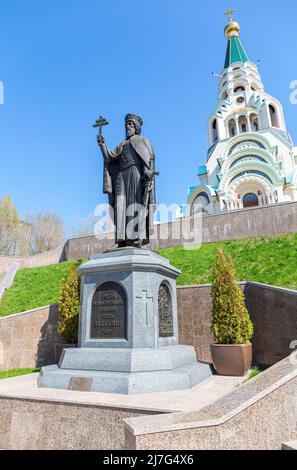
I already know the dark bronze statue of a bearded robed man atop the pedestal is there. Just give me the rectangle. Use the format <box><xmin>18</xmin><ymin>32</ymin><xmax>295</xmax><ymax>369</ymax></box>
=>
<box><xmin>97</xmin><ymin>114</ymin><xmax>156</xmax><ymax>247</ymax></box>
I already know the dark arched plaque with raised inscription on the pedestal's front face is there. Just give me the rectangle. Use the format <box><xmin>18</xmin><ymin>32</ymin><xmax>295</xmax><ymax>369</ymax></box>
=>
<box><xmin>91</xmin><ymin>282</ymin><xmax>127</xmax><ymax>339</ymax></box>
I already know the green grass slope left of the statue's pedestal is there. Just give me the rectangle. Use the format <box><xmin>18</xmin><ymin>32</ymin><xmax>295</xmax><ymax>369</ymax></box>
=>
<box><xmin>0</xmin><ymin>261</ymin><xmax>78</xmax><ymax>316</ymax></box>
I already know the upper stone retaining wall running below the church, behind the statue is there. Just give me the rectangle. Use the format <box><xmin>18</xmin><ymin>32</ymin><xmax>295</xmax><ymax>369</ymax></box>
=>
<box><xmin>64</xmin><ymin>202</ymin><xmax>297</xmax><ymax>260</ymax></box>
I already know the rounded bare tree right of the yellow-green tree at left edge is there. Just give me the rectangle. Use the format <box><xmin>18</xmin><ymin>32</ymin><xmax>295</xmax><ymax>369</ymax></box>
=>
<box><xmin>26</xmin><ymin>212</ymin><xmax>65</xmax><ymax>255</ymax></box>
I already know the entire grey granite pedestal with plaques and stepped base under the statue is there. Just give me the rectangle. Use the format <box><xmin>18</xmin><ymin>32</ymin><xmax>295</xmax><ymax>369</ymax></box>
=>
<box><xmin>38</xmin><ymin>248</ymin><xmax>212</xmax><ymax>394</ymax></box>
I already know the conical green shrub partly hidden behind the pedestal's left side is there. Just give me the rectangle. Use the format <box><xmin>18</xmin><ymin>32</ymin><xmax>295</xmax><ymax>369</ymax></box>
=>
<box><xmin>58</xmin><ymin>261</ymin><xmax>81</xmax><ymax>343</ymax></box>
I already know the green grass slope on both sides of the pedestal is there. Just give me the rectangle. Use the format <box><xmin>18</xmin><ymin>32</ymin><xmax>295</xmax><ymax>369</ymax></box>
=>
<box><xmin>0</xmin><ymin>233</ymin><xmax>297</xmax><ymax>316</ymax></box>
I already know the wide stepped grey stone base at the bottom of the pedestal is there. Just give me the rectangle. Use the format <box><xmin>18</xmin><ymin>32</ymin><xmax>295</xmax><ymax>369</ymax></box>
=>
<box><xmin>38</xmin><ymin>345</ymin><xmax>213</xmax><ymax>394</ymax></box>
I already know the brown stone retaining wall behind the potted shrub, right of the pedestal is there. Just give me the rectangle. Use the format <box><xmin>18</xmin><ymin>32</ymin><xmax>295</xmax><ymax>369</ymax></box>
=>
<box><xmin>177</xmin><ymin>282</ymin><xmax>297</xmax><ymax>366</ymax></box>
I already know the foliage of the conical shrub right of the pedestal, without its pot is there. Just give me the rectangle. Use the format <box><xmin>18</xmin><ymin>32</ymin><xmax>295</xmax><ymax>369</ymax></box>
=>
<box><xmin>211</xmin><ymin>249</ymin><xmax>253</xmax><ymax>344</ymax></box>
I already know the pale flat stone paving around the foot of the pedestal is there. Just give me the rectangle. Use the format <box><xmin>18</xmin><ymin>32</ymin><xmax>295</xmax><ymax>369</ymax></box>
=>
<box><xmin>0</xmin><ymin>374</ymin><xmax>244</xmax><ymax>412</ymax></box>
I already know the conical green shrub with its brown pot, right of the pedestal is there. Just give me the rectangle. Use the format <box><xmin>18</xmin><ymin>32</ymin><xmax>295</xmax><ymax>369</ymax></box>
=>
<box><xmin>211</xmin><ymin>249</ymin><xmax>253</xmax><ymax>376</ymax></box>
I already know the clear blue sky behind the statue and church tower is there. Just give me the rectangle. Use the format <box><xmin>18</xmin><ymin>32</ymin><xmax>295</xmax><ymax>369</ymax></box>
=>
<box><xmin>0</xmin><ymin>0</ymin><xmax>297</xmax><ymax>233</ymax></box>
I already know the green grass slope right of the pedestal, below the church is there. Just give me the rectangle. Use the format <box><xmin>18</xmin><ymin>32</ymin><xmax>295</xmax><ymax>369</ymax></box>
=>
<box><xmin>159</xmin><ymin>233</ymin><xmax>297</xmax><ymax>289</ymax></box>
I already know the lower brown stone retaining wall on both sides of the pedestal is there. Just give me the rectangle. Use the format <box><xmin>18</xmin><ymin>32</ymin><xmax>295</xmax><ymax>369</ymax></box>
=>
<box><xmin>0</xmin><ymin>283</ymin><xmax>297</xmax><ymax>370</ymax></box>
